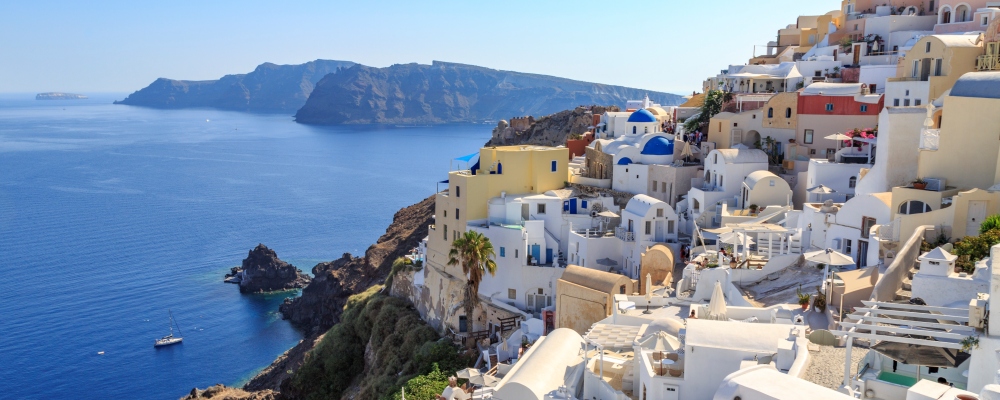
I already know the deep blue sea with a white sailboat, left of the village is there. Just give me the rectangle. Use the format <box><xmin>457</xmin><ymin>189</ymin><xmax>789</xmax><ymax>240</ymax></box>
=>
<box><xmin>0</xmin><ymin>94</ymin><xmax>492</xmax><ymax>399</ymax></box>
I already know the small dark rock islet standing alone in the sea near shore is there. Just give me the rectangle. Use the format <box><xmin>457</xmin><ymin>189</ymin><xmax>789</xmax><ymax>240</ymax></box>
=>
<box><xmin>239</xmin><ymin>244</ymin><xmax>309</xmax><ymax>293</ymax></box>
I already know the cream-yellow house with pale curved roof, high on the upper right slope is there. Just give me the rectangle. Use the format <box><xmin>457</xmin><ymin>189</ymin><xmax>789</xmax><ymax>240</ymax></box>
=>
<box><xmin>885</xmin><ymin>33</ymin><xmax>983</xmax><ymax>107</ymax></box>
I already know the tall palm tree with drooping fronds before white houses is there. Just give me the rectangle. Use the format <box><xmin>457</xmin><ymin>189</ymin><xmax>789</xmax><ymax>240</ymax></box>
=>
<box><xmin>448</xmin><ymin>231</ymin><xmax>497</xmax><ymax>332</ymax></box>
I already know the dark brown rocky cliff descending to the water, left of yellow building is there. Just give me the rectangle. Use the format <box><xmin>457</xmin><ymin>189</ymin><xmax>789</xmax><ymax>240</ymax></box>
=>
<box><xmin>280</xmin><ymin>196</ymin><xmax>434</xmax><ymax>335</ymax></box>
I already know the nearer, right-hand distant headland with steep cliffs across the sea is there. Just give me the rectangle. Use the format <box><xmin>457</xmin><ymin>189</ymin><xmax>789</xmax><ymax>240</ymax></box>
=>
<box><xmin>295</xmin><ymin>61</ymin><xmax>683</xmax><ymax>124</ymax></box>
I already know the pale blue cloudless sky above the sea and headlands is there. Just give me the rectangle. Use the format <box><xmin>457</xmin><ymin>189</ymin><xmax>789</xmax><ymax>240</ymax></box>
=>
<box><xmin>0</xmin><ymin>0</ymin><xmax>840</xmax><ymax>94</ymax></box>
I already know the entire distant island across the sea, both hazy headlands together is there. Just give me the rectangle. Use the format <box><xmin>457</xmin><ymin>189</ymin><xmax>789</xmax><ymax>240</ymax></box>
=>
<box><xmin>115</xmin><ymin>60</ymin><xmax>684</xmax><ymax>125</ymax></box>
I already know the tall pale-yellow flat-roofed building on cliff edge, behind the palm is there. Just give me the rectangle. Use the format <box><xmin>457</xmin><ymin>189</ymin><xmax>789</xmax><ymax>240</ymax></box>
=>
<box><xmin>424</xmin><ymin>146</ymin><xmax>569</xmax><ymax>332</ymax></box>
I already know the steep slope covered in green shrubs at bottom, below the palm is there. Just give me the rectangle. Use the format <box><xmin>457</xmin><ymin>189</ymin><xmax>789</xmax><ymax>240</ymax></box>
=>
<box><xmin>283</xmin><ymin>286</ymin><xmax>468</xmax><ymax>399</ymax></box>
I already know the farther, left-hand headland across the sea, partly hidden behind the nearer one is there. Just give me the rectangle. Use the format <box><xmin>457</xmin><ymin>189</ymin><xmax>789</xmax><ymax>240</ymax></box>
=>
<box><xmin>115</xmin><ymin>60</ymin><xmax>354</xmax><ymax>113</ymax></box>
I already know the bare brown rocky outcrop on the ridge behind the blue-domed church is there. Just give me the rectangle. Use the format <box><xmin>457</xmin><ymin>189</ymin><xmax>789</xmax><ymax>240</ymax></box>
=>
<box><xmin>486</xmin><ymin>106</ymin><xmax>619</xmax><ymax>146</ymax></box>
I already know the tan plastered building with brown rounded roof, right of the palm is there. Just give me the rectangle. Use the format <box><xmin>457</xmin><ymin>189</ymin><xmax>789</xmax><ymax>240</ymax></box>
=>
<box><xmin>556</xmin><ymin>265</ymin><xmax>635</xmax><ymax>335</ymax></box>
